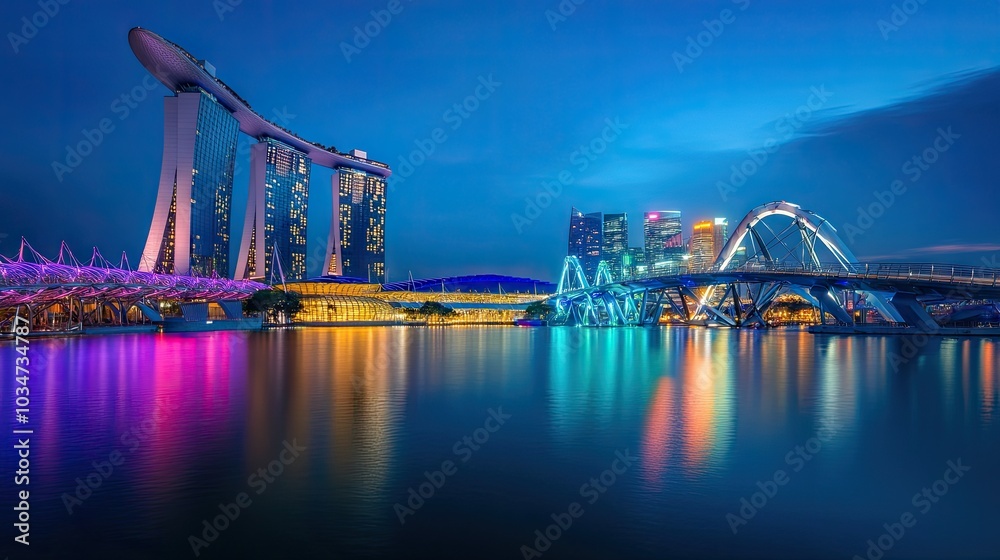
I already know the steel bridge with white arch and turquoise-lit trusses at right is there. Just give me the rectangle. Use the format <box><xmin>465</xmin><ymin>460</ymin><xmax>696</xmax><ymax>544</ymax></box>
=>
<box><xmin>546</xmin><ymin>202</ymin><xmax>1000</xmax><ymax>331</ymax></box>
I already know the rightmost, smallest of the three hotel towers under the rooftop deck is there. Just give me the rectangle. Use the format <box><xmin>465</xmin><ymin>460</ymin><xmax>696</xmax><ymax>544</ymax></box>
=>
<box><xmin>325</xmin><ymin>156</ymin><xmax>386</xmax><ymax>283</ymax></box>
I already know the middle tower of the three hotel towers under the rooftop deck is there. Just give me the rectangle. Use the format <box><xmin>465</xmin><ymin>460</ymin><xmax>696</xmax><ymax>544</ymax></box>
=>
<box><xmin>237</xmin><ymin>138</ymin><xmax>312</xmax><ymax>282</ymax></box>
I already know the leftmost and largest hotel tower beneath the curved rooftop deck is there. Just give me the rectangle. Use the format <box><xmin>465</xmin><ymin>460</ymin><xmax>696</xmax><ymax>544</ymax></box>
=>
<box><xmin>139</xmin><ymin>86</ymin><xmax>240</xmax><ymax>278</ymax></box>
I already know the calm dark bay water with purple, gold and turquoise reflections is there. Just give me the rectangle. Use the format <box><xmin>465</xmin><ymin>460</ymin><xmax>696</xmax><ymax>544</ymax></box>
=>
<box><xmin>0</xmin><ymin>327</ymin><xmax>1000</xmax><ymax>560</ymax></box>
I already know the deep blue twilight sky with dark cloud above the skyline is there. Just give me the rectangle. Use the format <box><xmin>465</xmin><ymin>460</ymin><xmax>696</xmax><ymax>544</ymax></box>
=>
<box><xmin>0</xmin><ymin>0</ymin><xmax>1000</xmax><ymax>280</ymax></box>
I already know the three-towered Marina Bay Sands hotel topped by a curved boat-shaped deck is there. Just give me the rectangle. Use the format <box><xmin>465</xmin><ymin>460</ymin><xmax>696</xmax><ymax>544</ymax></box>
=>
<box><xmin>128</xmin><ymin>28</ymin><xmax>392</xmax><ymax>283</ymax></box>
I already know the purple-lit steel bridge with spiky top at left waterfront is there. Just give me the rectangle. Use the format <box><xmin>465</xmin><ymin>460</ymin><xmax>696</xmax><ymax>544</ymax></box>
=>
<box><xmin>0</xmin><ymin>239</ymin><xmax>269</xmax><ymax>332</ymax></box>
